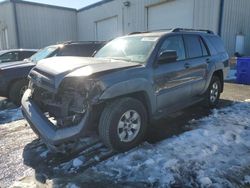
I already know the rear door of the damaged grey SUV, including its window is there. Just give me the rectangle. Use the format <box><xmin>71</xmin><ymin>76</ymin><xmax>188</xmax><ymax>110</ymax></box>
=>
<box><xmin>184</xmin><ymin>34</ymin><xmax>210</xmax><ymax>96</ymax></box>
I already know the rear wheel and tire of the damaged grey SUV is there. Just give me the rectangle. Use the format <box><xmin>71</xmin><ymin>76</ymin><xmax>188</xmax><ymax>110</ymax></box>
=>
<box><xmin>205</xmin><ymin>76</ymin><xmax>222</xmax><ymax>108</ymax></box>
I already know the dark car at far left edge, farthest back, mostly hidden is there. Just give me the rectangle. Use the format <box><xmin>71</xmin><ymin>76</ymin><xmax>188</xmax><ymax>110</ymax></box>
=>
<box><xmin>0</xmin><ymin>49</ymin><xmax>38</xmax><ymax>64</ymax></box>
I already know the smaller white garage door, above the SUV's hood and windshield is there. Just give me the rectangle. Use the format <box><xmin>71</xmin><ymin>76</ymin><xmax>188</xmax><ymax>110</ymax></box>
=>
<box><xmin>96</xmin><ymin>17</ymin><xmax>118</xmax><ymax>41</ymax></box>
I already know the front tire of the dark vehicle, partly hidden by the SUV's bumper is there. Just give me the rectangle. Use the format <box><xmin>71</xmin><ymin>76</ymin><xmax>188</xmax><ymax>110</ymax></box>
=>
<box><xmin>9</xmin><ymin>80</ymin><xmax>28</xmax><ymax>106</ymax></box>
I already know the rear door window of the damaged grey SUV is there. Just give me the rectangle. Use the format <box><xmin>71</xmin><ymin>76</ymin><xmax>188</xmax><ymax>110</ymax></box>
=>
<box><xmin>184</xmin><ymin>35</ymin><xmax>205</xmax><ymax>58</ymax></box>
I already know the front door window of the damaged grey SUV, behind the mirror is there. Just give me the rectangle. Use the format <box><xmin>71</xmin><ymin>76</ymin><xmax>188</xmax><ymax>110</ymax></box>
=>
<box><xmin>159</xmin><ymin>36</ymin><xmax>186</xmax><ymax>61</ymax></box>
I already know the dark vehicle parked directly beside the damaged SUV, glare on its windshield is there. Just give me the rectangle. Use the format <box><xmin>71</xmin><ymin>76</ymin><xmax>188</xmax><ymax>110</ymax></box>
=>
<box><xmin>0</xmin><ymin>42</ymin><xmax>104</xmax><ymax>105</ymax></box>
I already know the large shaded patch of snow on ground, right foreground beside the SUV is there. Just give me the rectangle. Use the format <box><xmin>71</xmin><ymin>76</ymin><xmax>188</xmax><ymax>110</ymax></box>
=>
<box><xmin>94</xmin><ymin>100</ymin><xmax>250</xmax><ymax>187</ymax></box>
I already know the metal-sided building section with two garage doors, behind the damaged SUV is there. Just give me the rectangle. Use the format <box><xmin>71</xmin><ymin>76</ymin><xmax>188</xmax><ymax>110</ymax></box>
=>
<box><xmin>77</xmin><ymin>0</ymin><xmax>250</xmax><ymax>55</ymax></box>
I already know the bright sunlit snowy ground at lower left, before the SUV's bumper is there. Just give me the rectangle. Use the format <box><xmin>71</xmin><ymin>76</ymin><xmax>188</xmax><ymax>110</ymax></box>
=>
<box><xmin>0</xmin><ymin>119</ymin><xmax>36</xmax><ymax>188</ymax></box>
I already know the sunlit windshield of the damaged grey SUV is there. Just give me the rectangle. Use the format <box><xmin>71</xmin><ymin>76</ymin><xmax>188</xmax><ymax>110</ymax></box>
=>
<box><xmin>95</xmin><ymin>36</ymin><xmax>158</xmax><ymax>63</ymax></box>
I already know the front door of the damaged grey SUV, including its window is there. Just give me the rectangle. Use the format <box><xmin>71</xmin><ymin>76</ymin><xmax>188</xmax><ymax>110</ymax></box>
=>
<box><xmin>154</xmin><ymin>35</ymin><xmax>191</xmax><ymax>110</ymax></box>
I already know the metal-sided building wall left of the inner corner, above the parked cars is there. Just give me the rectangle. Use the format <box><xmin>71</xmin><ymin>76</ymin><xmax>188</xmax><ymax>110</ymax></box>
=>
<box><xmin>0</xmin><ymin>0</ymin><xmax>77</xmax><ymax>49</ymax></box>
